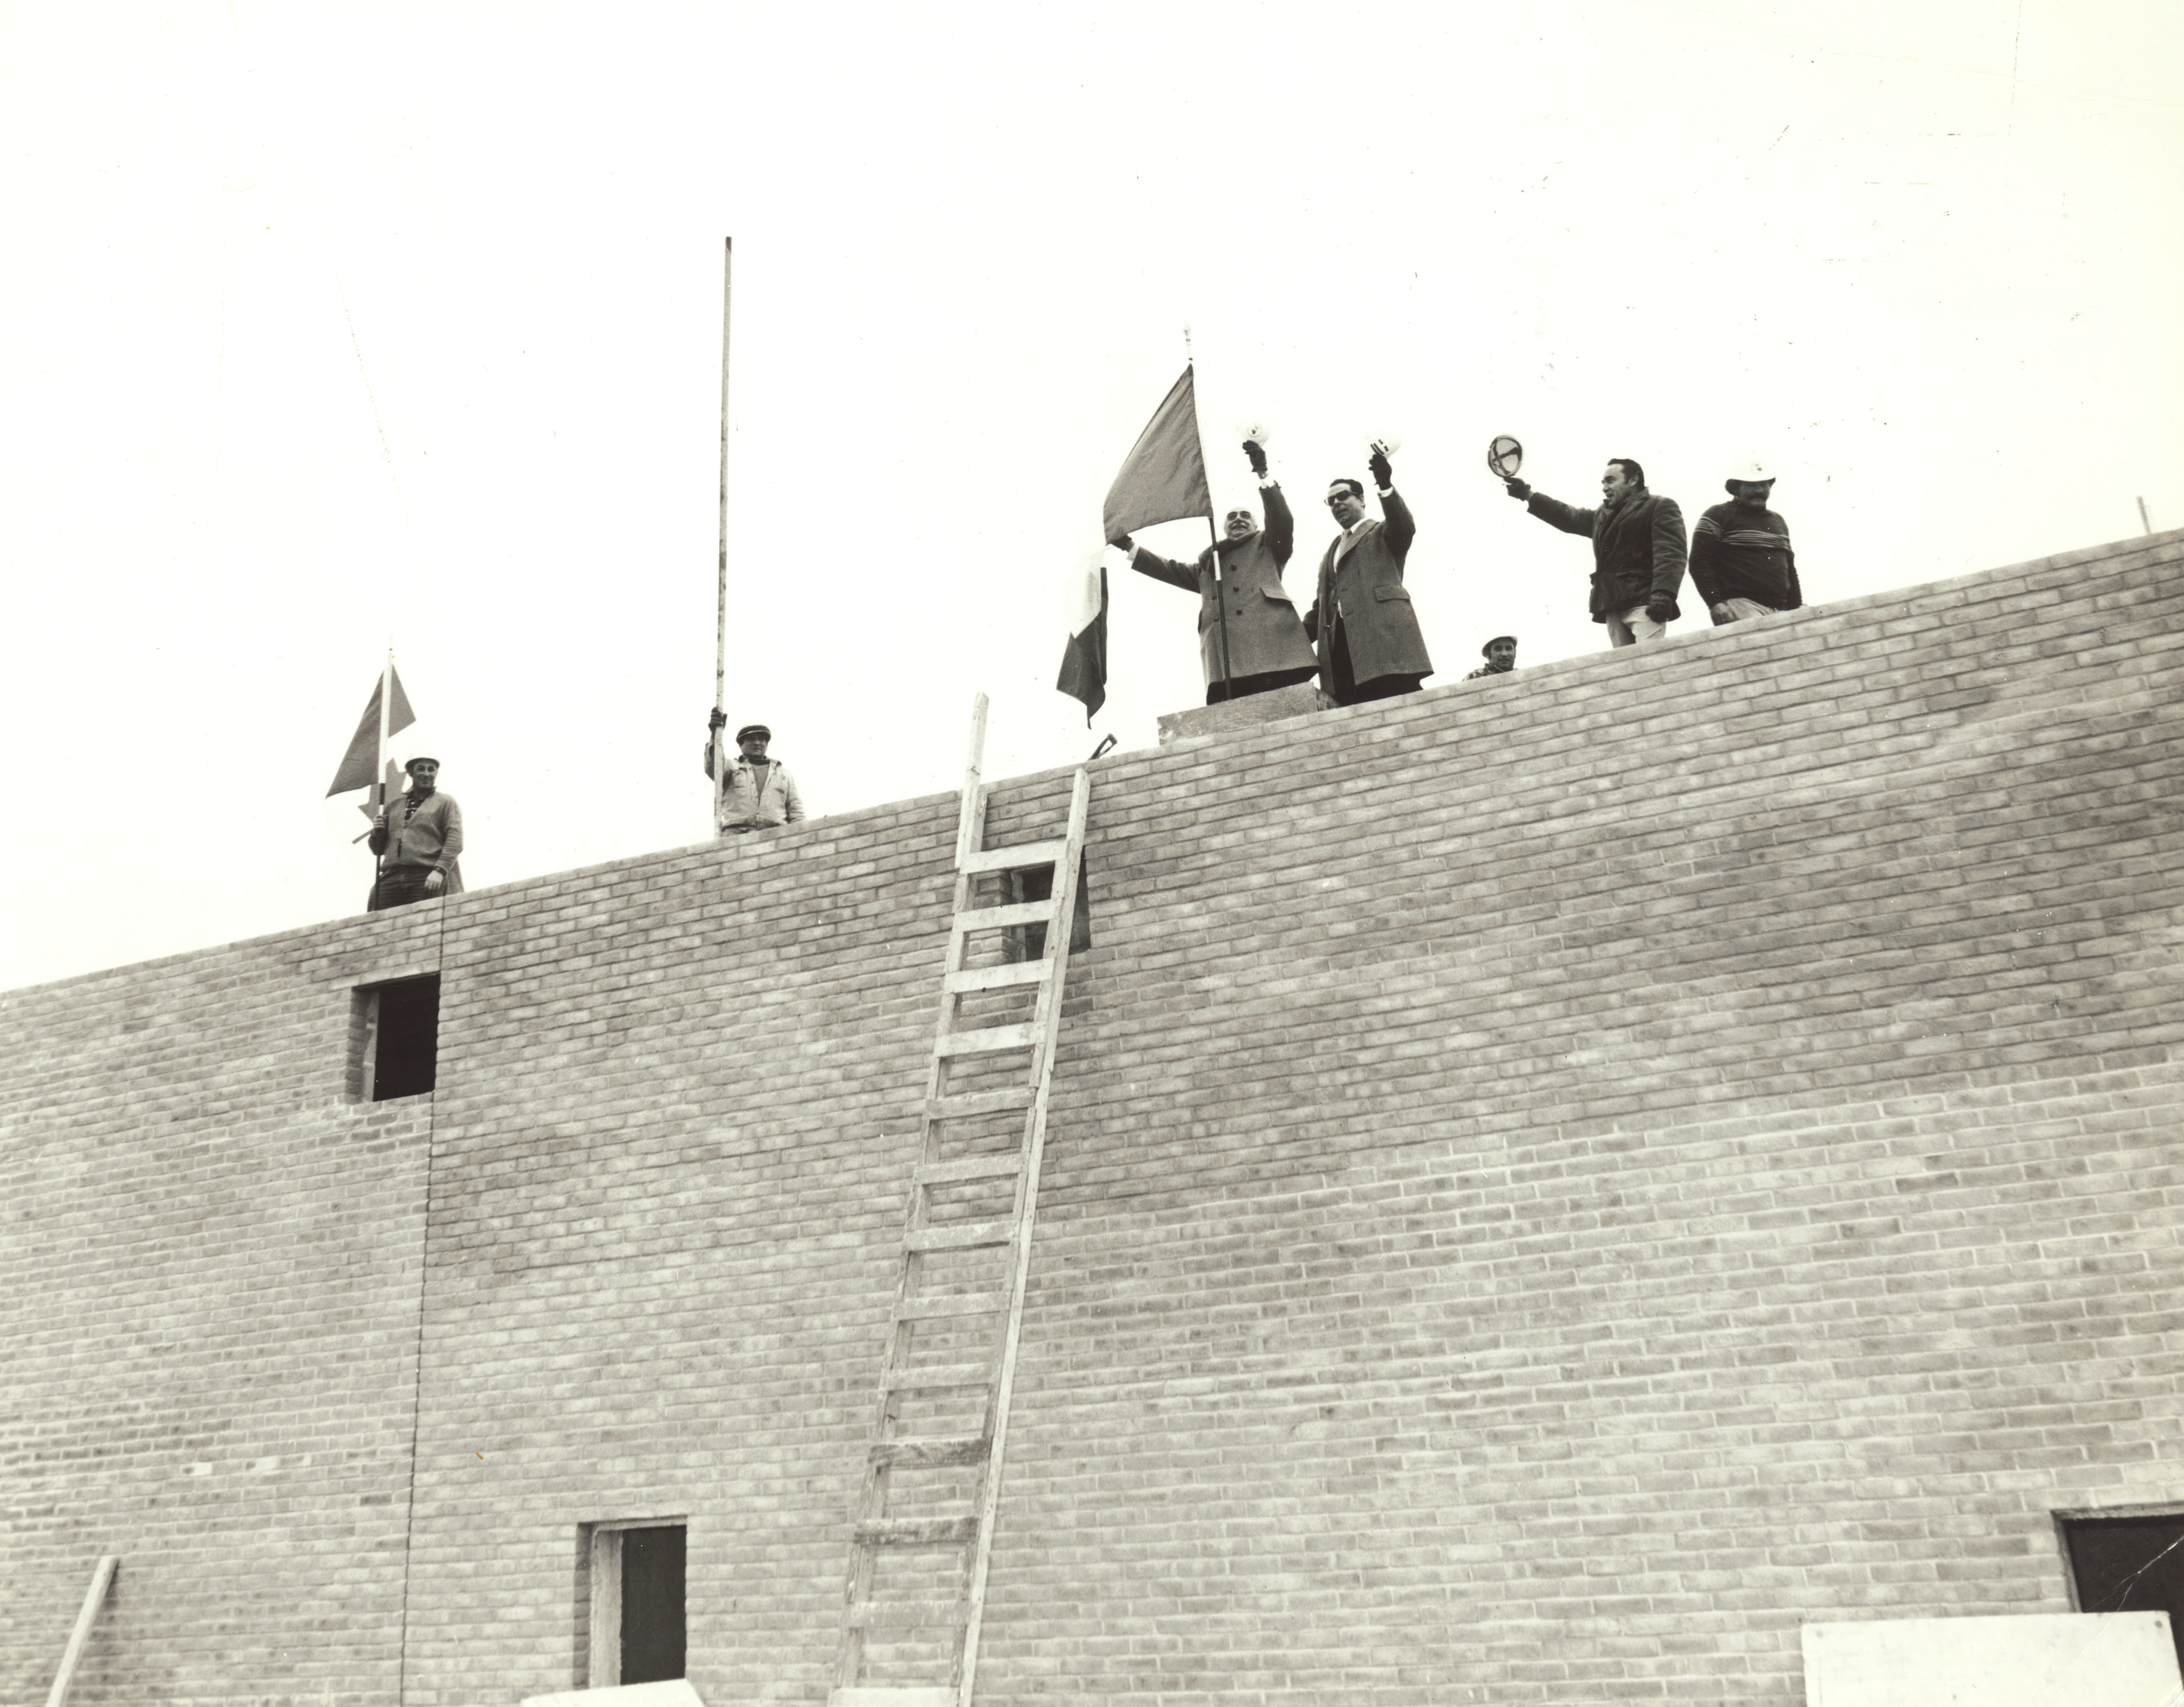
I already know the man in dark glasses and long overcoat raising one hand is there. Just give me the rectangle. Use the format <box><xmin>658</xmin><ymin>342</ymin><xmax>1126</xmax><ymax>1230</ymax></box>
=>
<box><xmin>1304</xmin><ymin>441</ymin><xmax>1433</xmax><ymax>705</ymax></box>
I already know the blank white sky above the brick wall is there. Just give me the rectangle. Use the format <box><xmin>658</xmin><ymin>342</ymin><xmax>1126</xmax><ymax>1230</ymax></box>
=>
<box><xmin>0</xmin><ymin>0</ymin><xmax>2184</xmax><ymax>987</ymax></box>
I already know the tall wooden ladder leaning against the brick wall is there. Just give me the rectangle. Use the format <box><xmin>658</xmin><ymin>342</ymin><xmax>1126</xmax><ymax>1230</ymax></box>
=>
<box><xmin>828</xmin><ymin>694</ymin><xmax>1092</xmax><ymax>1707</ymax></box>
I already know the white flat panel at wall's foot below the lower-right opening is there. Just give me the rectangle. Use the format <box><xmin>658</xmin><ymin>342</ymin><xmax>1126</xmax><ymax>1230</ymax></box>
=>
<box><xmin>1804</xmin><ymin>1613</ymin><xmax>2184</xmax><ymax>1707</ymax></box>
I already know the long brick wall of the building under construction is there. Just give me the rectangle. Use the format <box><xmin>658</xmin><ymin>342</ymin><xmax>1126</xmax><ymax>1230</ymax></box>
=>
<box><xmin>0</xmin><ymin>535</ymin><xmax>2184</xmax><ymax>1707</ymax></box>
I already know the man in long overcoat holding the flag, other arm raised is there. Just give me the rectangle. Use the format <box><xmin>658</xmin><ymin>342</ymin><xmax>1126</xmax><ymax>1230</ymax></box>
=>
<box><xmin>1107</xmin><ymin>439</ymin><xmax>1319</xmax><ymax>705</ymax></box>
